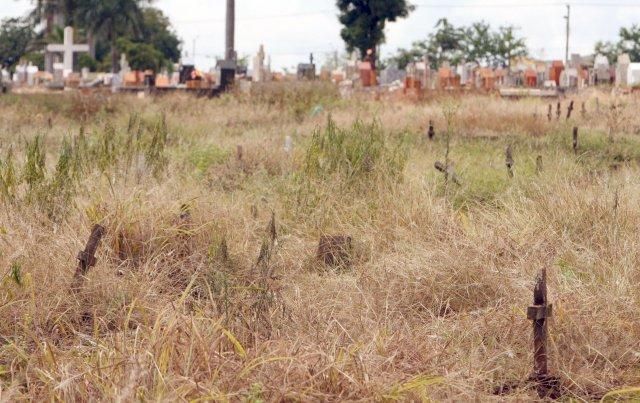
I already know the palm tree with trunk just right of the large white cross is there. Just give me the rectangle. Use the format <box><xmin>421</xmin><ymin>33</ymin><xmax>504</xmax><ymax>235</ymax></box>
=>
<box><xmin>77</xmin><ymin>0</ymin><xmax>152</xmax><ymax>73</ymax></box>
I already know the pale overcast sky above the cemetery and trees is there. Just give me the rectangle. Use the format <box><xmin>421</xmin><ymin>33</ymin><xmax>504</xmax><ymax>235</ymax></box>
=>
<box><xmin>0</xmin><ymin>0</ymin><xmax>640</xmax><ymax>69</ymax></box>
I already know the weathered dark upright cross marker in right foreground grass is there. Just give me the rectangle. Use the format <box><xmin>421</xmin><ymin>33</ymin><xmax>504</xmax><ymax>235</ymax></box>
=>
<box><xmin>527</xmin><ymin>268</ymin><xmax>559</xmax><ymax>398</ymax></box>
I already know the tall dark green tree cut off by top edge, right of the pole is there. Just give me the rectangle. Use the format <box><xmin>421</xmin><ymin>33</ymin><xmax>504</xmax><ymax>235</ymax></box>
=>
<box><xmin>336</xmin><ymin>0</ymin><xmax>414</xmax><ymax>68</ymax></box>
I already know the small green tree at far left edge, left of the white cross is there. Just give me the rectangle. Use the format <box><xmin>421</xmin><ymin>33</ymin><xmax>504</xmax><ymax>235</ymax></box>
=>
<box><xmin>0</xmin><ymin>18</ymin><xmax>35</xmax><ymax>67</ymax></box>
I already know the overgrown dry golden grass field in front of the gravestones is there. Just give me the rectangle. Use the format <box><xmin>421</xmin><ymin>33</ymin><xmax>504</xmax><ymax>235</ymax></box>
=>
<box><xmin>0</xmin><ymin>84</ymin><xmax>640</xmax><ymax>402</ymax></box>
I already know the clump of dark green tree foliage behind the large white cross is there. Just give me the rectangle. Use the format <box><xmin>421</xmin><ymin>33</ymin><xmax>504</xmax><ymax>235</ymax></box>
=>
<box><xmin>13</xmin><ymin>0</ymin><xmax>181</xmax><ymax>71</ymax></box>
